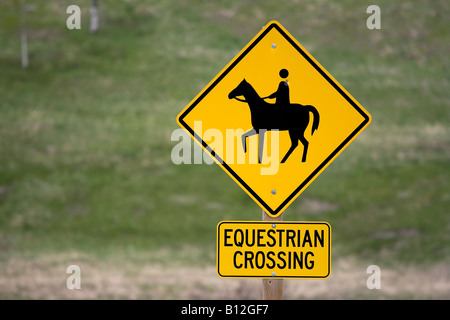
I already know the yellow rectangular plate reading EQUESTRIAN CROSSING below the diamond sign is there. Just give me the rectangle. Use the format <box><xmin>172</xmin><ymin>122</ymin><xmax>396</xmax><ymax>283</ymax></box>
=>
<box><xmin>217</xmin><ymin>221</ymin><xmax>331</xmax><ymax>279</ymax></box>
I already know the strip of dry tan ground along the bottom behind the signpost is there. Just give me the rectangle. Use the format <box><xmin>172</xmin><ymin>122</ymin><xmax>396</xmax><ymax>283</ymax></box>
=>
<box><xmin>0</xmin><ymin>253</ymin><xmax>450</xmax><ymax>300</ymax></box>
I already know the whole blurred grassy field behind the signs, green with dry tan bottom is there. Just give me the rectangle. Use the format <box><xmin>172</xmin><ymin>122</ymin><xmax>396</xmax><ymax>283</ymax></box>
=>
<box><xmin>0</xmin><ymin>0</ymin><xmax>450</xmax><ymax>299</ymax></box>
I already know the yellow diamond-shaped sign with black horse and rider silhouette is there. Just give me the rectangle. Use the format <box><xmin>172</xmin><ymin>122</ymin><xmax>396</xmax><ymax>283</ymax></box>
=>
<box><xmin>177</xmin><ymin>21</ymin><xmax>371</xmax><ymax>217</ymax></box>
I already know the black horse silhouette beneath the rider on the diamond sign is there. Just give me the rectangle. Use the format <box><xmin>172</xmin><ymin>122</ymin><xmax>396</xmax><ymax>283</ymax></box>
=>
<box><xmin>228</xmin><ymin>79</ymin><xmax>320</xmax><ymax>163</ymax></box>
